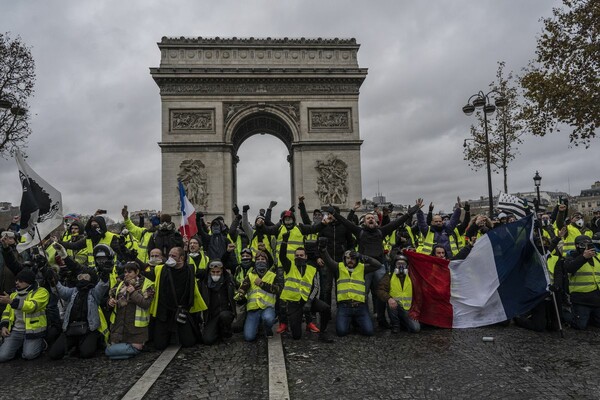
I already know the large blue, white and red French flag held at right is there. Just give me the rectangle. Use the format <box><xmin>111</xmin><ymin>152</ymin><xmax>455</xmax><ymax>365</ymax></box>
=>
<box><xmin>405</xmin><ymin>215</ymin><xmax>549</xmax><ymax>328</ymax></box>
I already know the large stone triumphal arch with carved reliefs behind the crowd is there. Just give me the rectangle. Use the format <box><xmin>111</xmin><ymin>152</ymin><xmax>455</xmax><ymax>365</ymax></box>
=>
<box><xmin>150</xmin><ymin>37</ymin><xmax>367</xmax><ymax>221</ymax></box>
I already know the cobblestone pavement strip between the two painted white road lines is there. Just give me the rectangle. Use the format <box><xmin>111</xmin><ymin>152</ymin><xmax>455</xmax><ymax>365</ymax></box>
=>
<box><xmin>144</xmin><ymin>335</ymin><xmax>269</xmax><ymax>400</ymax></box>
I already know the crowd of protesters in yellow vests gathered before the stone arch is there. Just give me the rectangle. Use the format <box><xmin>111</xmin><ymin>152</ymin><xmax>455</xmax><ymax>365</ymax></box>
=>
<box><xmin>0</xmin><ymin>197</ymin><xmax>600</xmax><ymax>362</ymax></box>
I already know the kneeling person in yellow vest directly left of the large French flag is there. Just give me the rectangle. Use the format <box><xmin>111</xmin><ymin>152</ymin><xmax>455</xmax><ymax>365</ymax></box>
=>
<box><xmin>377</xmin><ymin>254</ymin><xmax>421</xmax><ymax>333</ymax></box>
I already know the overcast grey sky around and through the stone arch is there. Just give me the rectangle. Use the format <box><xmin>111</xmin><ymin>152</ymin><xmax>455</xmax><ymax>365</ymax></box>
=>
<box><xmin>0</xmin><ymin>0</ymin><xmax>600</xmax><ymax>222</ymax></box>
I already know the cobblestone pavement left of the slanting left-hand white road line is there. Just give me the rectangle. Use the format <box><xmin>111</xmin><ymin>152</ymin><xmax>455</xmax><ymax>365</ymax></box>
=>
<box><xmin>0</xmin><ymin>351</ymin><xmax>160</xmax><ymax>400</ymax></box>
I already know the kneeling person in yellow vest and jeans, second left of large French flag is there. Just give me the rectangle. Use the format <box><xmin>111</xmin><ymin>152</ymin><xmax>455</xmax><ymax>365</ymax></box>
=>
<box><xmin>319</xmin><ymin>244</ymin><xmax>383</xmax><ymax>336</ymax></box>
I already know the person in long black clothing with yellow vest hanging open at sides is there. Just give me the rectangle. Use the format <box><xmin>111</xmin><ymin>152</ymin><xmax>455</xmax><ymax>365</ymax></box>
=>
<box><xmin>144</xmin><ymin>247</ymin><xmax>207</xmax><ymax>350</ymax></box>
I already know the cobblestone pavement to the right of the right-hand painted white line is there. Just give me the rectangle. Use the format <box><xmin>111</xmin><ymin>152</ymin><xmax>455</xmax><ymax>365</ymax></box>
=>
<box><xmin>283</xmin><ymin>326</ymin><xmax>600</xmax><ymax>400</ymax></box>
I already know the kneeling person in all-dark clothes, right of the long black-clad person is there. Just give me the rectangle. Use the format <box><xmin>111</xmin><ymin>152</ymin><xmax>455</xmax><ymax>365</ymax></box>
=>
<box><xmin>197</xmin><ymin>260</ymin><xmax>236</xmax><ymax>345</ymax></box>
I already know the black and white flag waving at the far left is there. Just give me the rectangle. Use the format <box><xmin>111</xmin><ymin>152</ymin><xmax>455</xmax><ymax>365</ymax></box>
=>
<box><xmin>15</xmin><ymin>151</ymin><xmax>63</xmax><ymax>253</ymax></box>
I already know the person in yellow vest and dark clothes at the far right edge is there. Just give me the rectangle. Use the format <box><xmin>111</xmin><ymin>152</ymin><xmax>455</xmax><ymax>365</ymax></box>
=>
<box><xmin>564</xmin><ymin>235</ymin><xmax>600</xmax><ymax>329</ymax></box>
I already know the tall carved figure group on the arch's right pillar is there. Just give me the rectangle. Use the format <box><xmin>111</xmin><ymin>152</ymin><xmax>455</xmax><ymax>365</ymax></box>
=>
<box><xmin>315</xmin><ymin>154</ymin><xmax>348</xmax><ymax>204</ymax></box>
